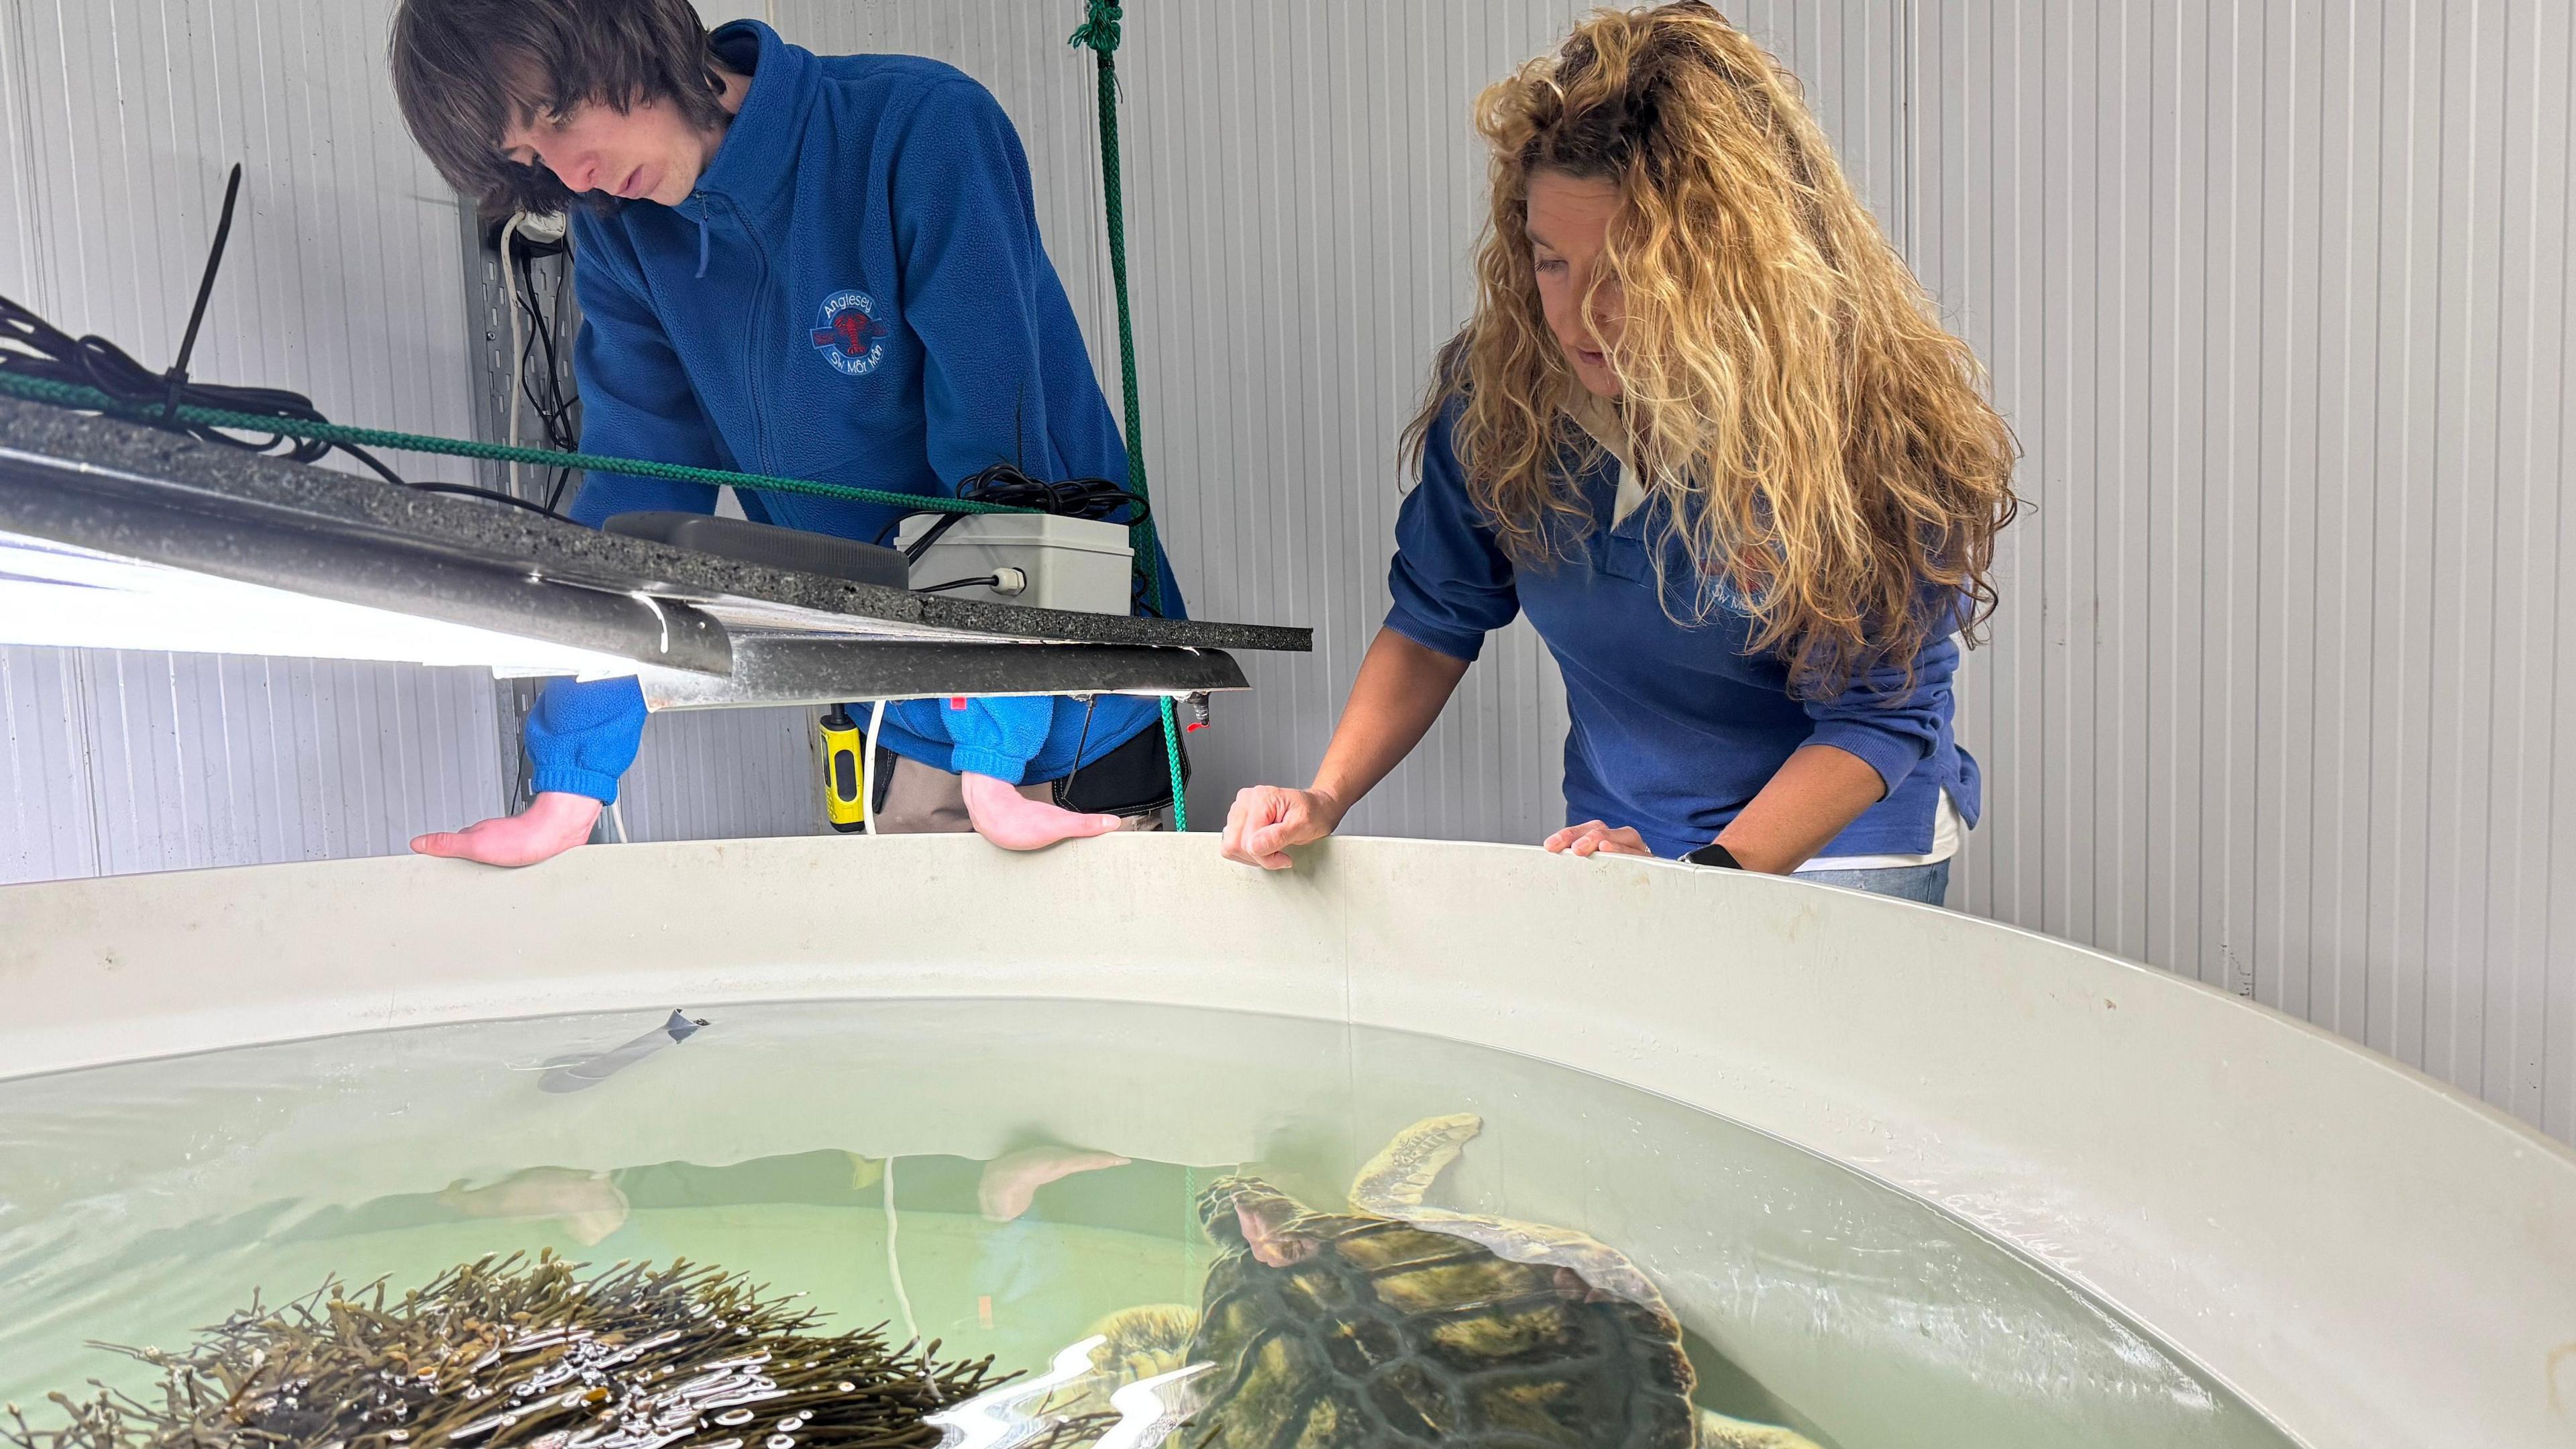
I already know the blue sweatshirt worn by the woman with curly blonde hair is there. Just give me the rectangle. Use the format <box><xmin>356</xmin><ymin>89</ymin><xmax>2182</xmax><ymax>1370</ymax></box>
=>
<box><xmin>1386</xmin><ymin>405</ymin><xmax>1978</xmax><ymax>856</ymax></box>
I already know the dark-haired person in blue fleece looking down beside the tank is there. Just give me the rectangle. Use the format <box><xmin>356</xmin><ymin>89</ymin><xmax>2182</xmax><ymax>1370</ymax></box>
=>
<box><xmin>392</xmin><ymin>0</ymin><xmax>1180</xmax><ymax>864</ymax></box>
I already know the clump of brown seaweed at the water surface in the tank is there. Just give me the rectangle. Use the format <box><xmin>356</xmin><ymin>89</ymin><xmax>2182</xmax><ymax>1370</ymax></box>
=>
<box><xmin>0</xmin><ymin>1253</ymin><xmax>1113</xmax><ymax>1449</ymax></box>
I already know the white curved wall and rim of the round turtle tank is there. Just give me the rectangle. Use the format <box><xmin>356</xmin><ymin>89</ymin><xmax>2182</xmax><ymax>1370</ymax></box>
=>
<box><xmin>0</xmin><ymin>835</ymin><xmax>2576</xmax><ymax>1446</ymax></box>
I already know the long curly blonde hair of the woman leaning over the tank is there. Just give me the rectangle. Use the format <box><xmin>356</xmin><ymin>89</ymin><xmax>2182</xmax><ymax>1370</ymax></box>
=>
<box><xmin>1407</xmin><ymin>0</ymin><xmax>2017</xmax><ymax>694</ymax></box>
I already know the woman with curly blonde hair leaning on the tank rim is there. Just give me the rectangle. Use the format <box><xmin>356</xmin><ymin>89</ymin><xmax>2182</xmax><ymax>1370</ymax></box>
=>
<box><xmin>1226</xmin><ymin>0</ymin><xmax>2015</xmax><ymax>902</ymax></box>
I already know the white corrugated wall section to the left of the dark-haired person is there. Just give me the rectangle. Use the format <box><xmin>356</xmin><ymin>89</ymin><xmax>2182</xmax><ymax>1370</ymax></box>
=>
<box><xmin>0</xmin><ymin>0</ymin><xmax>502</xmax><ymax>881</ymax></box>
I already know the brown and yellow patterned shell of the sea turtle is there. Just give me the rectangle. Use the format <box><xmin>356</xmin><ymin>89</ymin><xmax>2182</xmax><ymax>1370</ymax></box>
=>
<box><xmin>1183</xmin><ymin>1191</ymin><xmax>1695</xmax><ymax>1449</ymax></box>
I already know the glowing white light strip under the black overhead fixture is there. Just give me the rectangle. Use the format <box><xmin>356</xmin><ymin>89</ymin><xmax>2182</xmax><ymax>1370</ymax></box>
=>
<box><xmin>0</xmin><ymin>534</ymin><xmax>636</xmax><ymax>678</ymax></box>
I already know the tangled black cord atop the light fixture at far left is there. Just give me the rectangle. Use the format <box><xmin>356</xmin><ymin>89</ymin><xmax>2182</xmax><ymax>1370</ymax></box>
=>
<box><xmin>0</xmin><ymin>165</ymin><xmax>569</xmax><ymax>516</ymax></box>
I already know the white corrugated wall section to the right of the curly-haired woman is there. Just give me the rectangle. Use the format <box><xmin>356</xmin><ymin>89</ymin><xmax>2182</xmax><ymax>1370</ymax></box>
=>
<box><xmin>1901</xmin><ymin>0</ymin><xmax>2576</xmax><ymax>1137</ymax></box>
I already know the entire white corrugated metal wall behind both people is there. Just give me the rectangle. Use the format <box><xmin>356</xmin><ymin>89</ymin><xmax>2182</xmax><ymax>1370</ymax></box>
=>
<box><xmin>0</xmin><ymin>0</ymin><xmax>2576</xmax><ymax>1137</ymax></box>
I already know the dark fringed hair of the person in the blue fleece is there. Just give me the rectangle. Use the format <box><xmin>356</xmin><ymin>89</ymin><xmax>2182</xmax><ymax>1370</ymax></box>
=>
<box><xmin>389</xmin><ymin>0</ymin><xmax>724</xmax><ymax>217</ymax></box>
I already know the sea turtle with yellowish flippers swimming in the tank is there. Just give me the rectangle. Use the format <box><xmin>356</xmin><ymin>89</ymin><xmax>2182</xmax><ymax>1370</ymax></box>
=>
<box><xmin>1092</xmin><ymin>1114</ymin><xmax>1813</xmax><ymax>1449</ymax></box>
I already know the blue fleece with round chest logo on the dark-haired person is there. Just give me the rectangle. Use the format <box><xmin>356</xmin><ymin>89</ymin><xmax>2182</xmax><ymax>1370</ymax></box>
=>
<box><xmin>528</xmin><ymin>21</ymin><xmax>1183</xmax><ymax>799</ymax></box>
